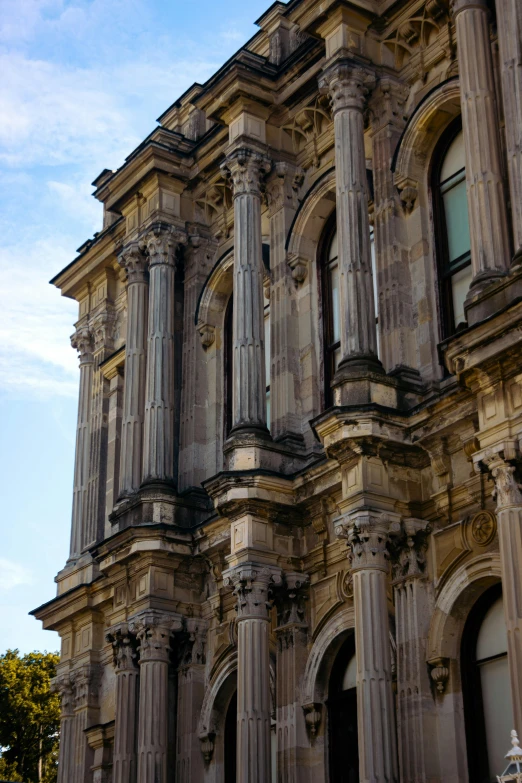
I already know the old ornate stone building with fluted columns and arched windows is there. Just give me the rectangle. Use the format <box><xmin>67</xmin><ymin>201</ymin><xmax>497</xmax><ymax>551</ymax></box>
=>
<box><xmin>34</xmin><ymin>0</ymin><xmax>522</xmax><ymax>783</ymax></box>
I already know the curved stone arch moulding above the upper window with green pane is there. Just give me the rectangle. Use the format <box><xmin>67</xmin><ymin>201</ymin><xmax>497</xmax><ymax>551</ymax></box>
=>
<box><xmin>392</xmin><ymin>77</ymin><xmax>461</xmax><ymax>202</ymax></box>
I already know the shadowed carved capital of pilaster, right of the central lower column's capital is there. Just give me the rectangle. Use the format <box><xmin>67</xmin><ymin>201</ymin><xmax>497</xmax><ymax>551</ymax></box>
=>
<box><xmin>389</xmin><ymin>517</ymin><xmax>431</xmax><ymax>582</ymax></box>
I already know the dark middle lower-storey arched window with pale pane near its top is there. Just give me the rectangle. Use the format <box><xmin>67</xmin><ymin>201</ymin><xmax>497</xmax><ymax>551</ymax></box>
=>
<box><xmin>327</xmin><ymin>631</ymin><xmax>359</xmax><ymax>783</ymax></box>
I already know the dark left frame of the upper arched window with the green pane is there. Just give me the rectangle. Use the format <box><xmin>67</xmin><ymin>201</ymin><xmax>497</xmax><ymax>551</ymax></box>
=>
<box><xmin>430</xmin><ymin>115</ymin><xmax>471</xmax><ymax>340</ymax></box>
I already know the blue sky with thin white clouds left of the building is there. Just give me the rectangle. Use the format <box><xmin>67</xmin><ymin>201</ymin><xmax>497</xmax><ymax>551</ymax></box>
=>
<box><xmin>0</xmin><ymin>0</ymin><xmax>270</xmax><ymax>653</ymax></box>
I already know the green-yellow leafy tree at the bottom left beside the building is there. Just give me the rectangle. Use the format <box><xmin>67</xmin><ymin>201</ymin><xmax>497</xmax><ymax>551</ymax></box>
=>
<box><xmin>0</xmin><ymin>650</ymin><xmax>60</xmax><ymax>783</ymax></box>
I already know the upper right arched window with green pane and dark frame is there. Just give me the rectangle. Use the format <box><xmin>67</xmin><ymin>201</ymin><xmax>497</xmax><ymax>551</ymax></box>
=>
<box><xmin>432</xmin><ymin>118</ymin><xmax>472</xmax><ymax>337</ymax></box>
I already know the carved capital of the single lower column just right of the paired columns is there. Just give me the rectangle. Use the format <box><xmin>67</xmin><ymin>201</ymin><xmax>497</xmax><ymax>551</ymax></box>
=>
<box><xmin>223</xmin><ymin>563</ymin><xmax>283</xmax><ymax>620</ymax></box>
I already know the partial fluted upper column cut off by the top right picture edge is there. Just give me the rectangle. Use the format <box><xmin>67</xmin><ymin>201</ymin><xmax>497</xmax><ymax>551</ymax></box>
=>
<box><xmin>495</xmin><ymin>0</ymin><xmax>522</xmax><ymax>263</ymax></box>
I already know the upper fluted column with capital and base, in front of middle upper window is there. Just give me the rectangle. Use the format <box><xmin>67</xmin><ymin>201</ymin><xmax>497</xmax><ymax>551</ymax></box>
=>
<box><xmin>314</xmin><ymin>58</ymin><xmax>382</xmax><ymax>374</ymax></box>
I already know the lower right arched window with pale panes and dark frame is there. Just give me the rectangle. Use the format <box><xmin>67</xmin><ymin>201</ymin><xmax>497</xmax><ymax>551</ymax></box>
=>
<box><xmin>461</xmin><ymin>585</ymin><xmax>514</xmax><ymax>783</ymax></box>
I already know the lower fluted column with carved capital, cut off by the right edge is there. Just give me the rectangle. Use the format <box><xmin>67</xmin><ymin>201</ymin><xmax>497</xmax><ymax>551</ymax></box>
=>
<box><xmin>483</xmin><ymin>453</ymin><xmax>522</xmax><ymax>731</ymax></box>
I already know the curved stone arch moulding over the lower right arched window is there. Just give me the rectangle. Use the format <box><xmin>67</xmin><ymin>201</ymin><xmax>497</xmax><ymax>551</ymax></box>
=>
<box><xmin>427</xmin><ymin>552</ymin><xmax>501</xmax><ymax>662</ymax></box>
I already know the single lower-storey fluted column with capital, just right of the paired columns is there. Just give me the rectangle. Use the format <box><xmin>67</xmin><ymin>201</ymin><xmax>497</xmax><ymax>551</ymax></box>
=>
<box><xmin>223</xmin><ymin>563</ymin><xmax>281</xmax><ymax>783</ymax></box>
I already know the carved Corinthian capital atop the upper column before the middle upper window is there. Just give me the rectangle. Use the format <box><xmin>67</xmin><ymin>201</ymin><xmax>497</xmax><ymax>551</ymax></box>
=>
<box><xmin>319</xmin><ymin>59</ymin><xmax>375</xmax><ymax>114</ymax></box>
